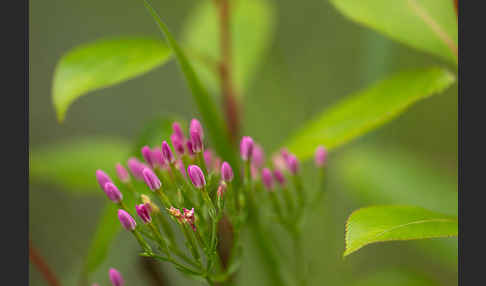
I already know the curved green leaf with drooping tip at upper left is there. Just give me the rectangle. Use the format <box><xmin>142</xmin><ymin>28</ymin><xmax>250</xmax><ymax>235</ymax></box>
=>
<box><xmin>52</xmin><ymin>37</ymin><xmax>171</xmax><ymax>122</ymax></box>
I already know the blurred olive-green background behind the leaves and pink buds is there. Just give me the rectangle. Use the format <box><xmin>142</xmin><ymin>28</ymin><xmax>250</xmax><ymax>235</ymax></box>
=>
<box><xmin>29</xmin><ymin>0</ymin><xmax>458</xmax><ymax>285</ymax></box>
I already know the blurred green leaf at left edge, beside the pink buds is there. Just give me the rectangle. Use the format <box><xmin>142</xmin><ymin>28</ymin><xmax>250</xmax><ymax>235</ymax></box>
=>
<box><xmin>30</xmin><ymin>137</ymin><xmax>130</xmax><ymax>194</ymax></box>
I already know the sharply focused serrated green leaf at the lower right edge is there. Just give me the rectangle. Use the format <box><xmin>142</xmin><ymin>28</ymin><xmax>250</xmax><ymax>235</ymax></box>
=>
<box><xmin>344</xmin><ymin>205</ymin><xmax>458</xmax><ymax>256</ymax></box>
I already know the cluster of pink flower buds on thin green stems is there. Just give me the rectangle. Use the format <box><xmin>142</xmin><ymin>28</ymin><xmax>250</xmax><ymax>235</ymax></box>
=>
<box><xmin>96</xmin><ymin>119</ymin><xmax>327</xmax><ymax>280</ymax></box>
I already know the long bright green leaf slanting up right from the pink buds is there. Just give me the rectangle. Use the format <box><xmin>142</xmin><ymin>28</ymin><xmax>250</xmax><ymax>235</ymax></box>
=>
<box><xmin>284</xmin><ymin>68</ymin><xmax>455</xmax><ymax>159</ymax></box>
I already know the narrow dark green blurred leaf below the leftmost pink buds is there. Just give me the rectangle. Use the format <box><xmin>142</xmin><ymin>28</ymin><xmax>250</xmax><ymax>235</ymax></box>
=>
<box><xmin>83</xmin><ymin>202</ymin><xmax>121</xmax><ymax>275</ymax></box>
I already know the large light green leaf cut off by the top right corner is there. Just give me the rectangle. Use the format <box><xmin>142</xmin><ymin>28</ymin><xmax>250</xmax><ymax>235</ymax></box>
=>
<box><xmin>331</xmin><ymin>0</ymin><xmax>458</xmax><ymax>64</ymax></box>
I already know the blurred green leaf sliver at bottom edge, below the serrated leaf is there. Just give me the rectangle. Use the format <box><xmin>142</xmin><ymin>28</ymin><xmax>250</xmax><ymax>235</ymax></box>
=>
<box><xmin>353</xmin><ymin>269</ymin><xmax>440</xmax><ymax>286</ymax></box>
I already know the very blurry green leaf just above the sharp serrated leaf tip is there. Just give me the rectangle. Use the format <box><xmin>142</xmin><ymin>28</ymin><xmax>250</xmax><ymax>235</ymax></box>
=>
<box><xmin>333</xmin><ymin>147</ymin><xmax>458</xmax><ymax>215</ymax></box>
